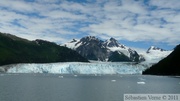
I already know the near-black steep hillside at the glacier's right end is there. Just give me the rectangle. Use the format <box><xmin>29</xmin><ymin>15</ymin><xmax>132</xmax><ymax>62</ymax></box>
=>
<box><xmin>143</xmin><ymin>45</ymin><xmax>180</xmax><ymax>75</ymax></box>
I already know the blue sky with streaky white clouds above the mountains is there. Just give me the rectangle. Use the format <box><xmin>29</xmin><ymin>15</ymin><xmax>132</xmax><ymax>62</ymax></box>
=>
<box><xmin>0</xmin><ymin>0</ymin><xmax>180</xmax><ymax>50</ymax></box>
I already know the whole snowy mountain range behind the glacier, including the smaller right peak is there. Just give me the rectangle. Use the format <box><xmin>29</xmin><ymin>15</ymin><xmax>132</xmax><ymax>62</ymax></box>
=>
<box><xmin>62</xmin><ymin>36</ymin><xmax>172</xmax><ymax>63</ymax></box>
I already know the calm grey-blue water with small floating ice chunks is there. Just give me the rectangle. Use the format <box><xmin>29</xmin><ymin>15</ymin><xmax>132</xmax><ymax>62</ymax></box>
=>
<box><xmin>0</xmin><ymin>74</ymin><xmax>180</xmax><ymax>101</ymax></box>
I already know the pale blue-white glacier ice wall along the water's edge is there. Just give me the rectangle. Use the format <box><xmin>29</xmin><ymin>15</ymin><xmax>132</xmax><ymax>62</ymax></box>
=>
<box><xmin>1</xmin><ymin>62</ymin><xmax>151</xmax><ymax>74</ymax></box>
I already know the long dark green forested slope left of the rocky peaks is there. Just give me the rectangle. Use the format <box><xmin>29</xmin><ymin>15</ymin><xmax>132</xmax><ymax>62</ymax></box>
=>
<box><xmin>0</xmin><ymin>33</ymin><xmax>88</xmax><ymax>65</ymax></box>
